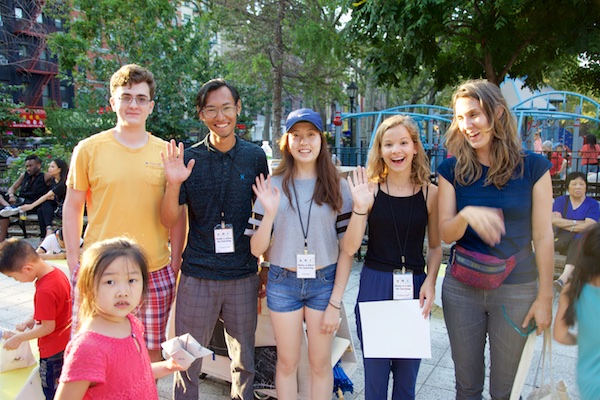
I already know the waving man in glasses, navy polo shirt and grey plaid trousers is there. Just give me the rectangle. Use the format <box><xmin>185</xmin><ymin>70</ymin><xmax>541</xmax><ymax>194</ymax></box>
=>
<box><xmin>161</xmin><ymin>79</ymin><xmax>268</xmax><ymax>400</ymax></box>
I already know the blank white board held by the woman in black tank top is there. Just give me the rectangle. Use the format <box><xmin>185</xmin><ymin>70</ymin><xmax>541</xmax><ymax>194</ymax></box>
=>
<box><xmin>358</xmin><ymin>300</ymin><xmax>431</xmax><ymax>358</ymax></box>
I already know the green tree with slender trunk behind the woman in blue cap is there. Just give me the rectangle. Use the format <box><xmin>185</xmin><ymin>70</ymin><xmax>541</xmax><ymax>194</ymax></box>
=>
<box><xmin>209</xmin><ymin>0</ymin><xmax>348</xmax><ymax>152</ymax></box>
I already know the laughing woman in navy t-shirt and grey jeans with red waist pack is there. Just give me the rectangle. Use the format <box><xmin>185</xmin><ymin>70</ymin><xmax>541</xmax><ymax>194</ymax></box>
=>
<box><xmin>438</xmin><ymin>80</ymin><xmax>554</xmax><ymax>399</ymax></box>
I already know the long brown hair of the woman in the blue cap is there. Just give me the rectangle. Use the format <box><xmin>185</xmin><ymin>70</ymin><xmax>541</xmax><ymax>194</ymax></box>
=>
<box><xmin>273</xmin><ymin>125</ymin><xmax>343</xmax><ymax>212</ymax></box>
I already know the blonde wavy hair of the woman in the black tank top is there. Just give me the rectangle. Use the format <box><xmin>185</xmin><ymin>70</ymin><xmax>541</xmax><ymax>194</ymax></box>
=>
<box><xmin>367</xmin><ymin>114</ymin><xmax>431</xmax><ymax>186</ymax></box>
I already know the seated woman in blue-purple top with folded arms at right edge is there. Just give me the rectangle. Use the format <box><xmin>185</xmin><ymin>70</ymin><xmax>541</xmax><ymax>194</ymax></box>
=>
<box><xmin>552</xmin><ymin>172</ymin><xmax>600</xmax><ymax>293</ymax></box>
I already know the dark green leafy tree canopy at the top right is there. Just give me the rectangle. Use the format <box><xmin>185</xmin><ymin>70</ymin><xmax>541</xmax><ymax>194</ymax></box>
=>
<box><xmin>350</xmin><ymin>0</ymin><xmax>598</xmax><ymax>88</ymax></box>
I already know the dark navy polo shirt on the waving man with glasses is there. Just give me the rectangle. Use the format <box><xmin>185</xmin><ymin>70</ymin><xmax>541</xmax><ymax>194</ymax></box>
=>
<box><xmin>179</xmin><ymin>134</ymin><xmax>269</xmax><ymax>280</ymax></box>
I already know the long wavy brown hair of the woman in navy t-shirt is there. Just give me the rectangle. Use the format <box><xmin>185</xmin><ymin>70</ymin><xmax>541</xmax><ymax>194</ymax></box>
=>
<box><xmin>446</xmin><ymin>79</ymin><xmax>525</xmax><ymax>189</ymax></box>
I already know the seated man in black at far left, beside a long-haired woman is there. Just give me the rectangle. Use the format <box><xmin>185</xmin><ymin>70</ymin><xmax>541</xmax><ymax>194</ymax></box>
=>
<box><xmin>0</xmin><ymin>154</ymin><xmax>50</xmax><ymax>242</ymax></box>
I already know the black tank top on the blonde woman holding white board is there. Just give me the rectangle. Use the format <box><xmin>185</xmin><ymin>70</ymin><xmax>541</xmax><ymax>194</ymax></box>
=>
<box><xmin>365</xmin><ymin>189</ymin><xmax>428</xmax><ymax>274</ymax></box>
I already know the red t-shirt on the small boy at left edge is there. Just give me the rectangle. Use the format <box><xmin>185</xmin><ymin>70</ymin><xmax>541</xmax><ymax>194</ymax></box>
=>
<box><xmin>33</xmin><ymin>268</ymin><xmax>71</xmax><ymax>358</ymax></box>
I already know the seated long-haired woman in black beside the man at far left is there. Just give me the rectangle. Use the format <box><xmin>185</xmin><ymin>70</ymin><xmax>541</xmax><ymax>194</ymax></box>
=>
<box><xmin>13</xmin><ymin>158</ymin><xmax>69</xmax><ymax>236</ymax></box>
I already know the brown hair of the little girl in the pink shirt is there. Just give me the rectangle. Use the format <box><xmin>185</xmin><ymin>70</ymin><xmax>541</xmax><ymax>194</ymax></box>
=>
<box><xmin>77</xmin><ymin>237</ymin><xmax>148</xmax><ymax>326</ymax></box>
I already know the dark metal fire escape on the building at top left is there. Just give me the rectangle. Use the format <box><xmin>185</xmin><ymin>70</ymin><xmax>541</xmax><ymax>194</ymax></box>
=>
<box><xmin>14</xmin><ymin>0</ymin><xmax>60</xmax><ymax>108</ymax></box>
